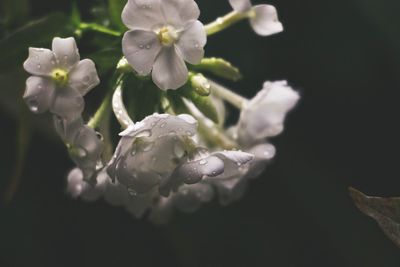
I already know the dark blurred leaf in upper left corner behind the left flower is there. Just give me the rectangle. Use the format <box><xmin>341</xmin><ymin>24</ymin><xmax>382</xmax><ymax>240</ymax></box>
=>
<box><xmin>0</xmin><ymin>13</ymin><xmax>69</xmax><ymax>73</ymax></box>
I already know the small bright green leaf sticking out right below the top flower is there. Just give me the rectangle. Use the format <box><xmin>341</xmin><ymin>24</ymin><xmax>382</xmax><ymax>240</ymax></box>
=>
<box><xmin>190</xmin><ymin>57</ymin><xmax>242</xmax><ymax>81</ymax></box>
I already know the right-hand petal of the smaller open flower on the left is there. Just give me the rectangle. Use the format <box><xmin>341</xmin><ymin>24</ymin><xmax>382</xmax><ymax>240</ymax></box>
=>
<box><xmin>68</xmin><ymin>59</ymin><xmax>100</xmax><ymax>96</ymax></box>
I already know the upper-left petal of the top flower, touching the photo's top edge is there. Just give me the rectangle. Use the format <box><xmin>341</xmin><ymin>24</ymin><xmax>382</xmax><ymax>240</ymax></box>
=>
<box><xmin>121</xmin><ymin>0</ymin><xmax>165</xmax><ymax>30</ymax></box>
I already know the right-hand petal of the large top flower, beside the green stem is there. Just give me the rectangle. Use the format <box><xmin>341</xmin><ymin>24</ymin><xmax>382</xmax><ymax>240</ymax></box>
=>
<box><xmin>176</xmin><ymin>20</ymin><xmax>207</xmax><ymax>65</ymax></box>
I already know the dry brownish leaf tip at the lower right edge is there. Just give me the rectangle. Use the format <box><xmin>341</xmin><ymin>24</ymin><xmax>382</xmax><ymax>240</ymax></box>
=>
<box><xmin>349</xmin><ymin>188</ymin><xmax>400</xmax><ymax>248</ymax></box>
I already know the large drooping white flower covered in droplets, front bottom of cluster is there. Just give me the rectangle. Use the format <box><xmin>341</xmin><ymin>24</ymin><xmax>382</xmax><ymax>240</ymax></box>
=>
<box><xmin>107</xmin><ymin>114</ymin><xmax>197</xmax><ymax>195</ymax></box>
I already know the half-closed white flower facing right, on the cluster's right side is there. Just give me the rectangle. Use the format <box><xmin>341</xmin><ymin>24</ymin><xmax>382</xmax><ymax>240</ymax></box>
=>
<box><xmin>237</xmin><ymin>81</ymin><xmax>300</xmax><ymax>148</ymax></box>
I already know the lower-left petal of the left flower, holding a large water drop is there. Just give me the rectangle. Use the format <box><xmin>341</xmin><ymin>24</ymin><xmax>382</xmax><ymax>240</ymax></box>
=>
<box><xmin>24</xmin><ymin>76</ymin><xmax>55</xmax><ymax>113</ymax></box>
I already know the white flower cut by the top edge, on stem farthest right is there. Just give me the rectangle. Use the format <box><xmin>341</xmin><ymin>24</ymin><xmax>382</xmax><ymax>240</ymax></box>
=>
<box><xmin>229</xmin><ymin>0</ymin><xmax>283</xmax><ymax>36</ymax></box>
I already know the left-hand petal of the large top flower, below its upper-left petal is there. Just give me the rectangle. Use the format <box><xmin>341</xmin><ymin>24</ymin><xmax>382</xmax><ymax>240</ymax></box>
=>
<box><xmin>122</xmin><ymin>30</ymin><xmax>161</xmax><ymax>75</ymax></box>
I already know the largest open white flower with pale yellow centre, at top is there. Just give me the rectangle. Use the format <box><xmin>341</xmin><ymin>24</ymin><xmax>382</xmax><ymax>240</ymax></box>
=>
<box><xmin>122</xmin><ymin>0</ymin><xmax>207</xmax><ymax>90</ymax></box>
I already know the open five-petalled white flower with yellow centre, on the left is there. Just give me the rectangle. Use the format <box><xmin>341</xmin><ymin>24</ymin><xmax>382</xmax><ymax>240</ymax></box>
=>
<box><xmin>24</xmin><ymin>37</ymin><xmax>100</xmax><ymax>120</ymax></box>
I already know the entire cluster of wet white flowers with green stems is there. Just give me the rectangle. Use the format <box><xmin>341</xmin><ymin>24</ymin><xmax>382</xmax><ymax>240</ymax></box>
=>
<box><xmin>24</xmin><ymin>0</ymin><xmax>299</xmax><ymax>223</ymax></box>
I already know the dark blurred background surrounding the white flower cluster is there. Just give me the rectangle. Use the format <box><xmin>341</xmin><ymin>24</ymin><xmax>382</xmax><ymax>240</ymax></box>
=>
<box><xmin>0</xmin><ymin>0</ymin><xmax>400</xmax><ymax>267</ymax></box>
